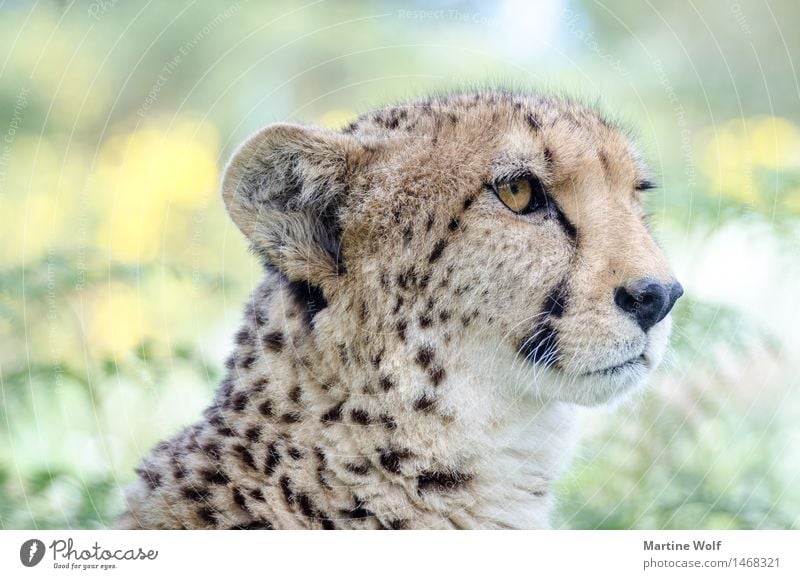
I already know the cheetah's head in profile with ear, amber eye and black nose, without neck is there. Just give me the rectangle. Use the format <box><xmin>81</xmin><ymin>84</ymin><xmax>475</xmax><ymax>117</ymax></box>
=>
<box><xmin>223</xmin><ymin>92</ymin><xmax>683</xmax><ymax>405</ymax></box>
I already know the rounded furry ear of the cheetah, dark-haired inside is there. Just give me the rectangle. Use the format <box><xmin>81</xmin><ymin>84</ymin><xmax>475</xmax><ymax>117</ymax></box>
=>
<box><xmin>222</xmin><ymin>124</ymin><xmax>361</xmax><ymax>287</ymax></box>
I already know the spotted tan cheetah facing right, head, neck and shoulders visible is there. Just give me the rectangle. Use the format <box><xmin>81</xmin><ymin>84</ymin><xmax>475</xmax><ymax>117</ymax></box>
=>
<box><xmin>117</xmin><ymin>90</ymin><xmax>683</xmax><ymax>529</ymax></box>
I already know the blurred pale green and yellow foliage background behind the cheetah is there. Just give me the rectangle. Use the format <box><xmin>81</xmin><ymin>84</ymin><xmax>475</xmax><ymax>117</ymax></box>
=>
<box><xmin>0</xmin><ymin>0</ymin><xmax>800</xmax><ymax>529</ymax></box>
